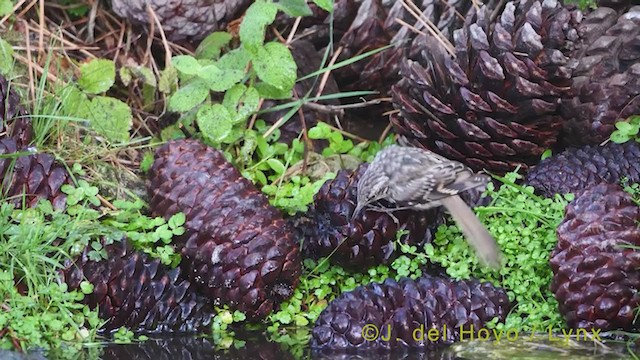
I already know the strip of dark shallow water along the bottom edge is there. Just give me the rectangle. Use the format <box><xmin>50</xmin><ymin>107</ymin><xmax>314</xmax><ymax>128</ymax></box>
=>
<box><xmin>6</xmin><ymin>334</ymin><xmax>638</xmax><ymax>360</ymax></box>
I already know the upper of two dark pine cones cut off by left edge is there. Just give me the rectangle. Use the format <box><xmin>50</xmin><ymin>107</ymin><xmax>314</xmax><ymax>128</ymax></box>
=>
<box><xmin>0</xmin><ymin>75</ymin><xmax>33</xmax><ymax>149</ymax></box>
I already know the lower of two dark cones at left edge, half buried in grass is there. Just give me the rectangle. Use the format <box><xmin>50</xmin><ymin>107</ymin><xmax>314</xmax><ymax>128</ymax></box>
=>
<box><xmin>0</xmin><ymin>137</ymin><xmax>72</xmax><ymax>209</ymax></box>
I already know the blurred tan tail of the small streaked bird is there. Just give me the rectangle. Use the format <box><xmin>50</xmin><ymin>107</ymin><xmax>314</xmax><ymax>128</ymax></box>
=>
<box><xmin>440</xmin><ymin>195</ymin><xmax>502</xmax><ymax>269</ymax></box>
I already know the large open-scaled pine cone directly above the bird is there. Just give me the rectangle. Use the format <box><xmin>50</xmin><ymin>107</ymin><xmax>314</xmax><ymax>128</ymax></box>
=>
<box><xmin>391</xmin><ymin>0</ymin><xmax>580</xmax><ymax>173</ymax></box>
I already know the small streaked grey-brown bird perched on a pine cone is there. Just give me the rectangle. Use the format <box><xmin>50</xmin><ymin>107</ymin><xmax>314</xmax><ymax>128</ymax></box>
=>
<box><xmin>352</xmin><ymin>145</ymin><xmax>502</xmax><ymax>269</ymax></box>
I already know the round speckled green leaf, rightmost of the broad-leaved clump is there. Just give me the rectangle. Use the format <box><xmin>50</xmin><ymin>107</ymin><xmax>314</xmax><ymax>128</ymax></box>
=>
<box><xmin>252</xmin><ymin>42</ymin><xmax>297</xmax><ymax>91</ymax></box>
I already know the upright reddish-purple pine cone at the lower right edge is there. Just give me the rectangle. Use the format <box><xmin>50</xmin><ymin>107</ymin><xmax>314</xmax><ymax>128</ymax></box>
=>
<box><xmin>550</xmin><ymin>184</ymin><xmax>640</xmax><ymax>331</ymax></box>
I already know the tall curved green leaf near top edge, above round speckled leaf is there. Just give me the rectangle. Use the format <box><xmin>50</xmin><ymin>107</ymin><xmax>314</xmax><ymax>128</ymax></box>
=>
<box><xmin>239</xmin><ymin>0</ymin><xmax>278</xmax><ymax>53</ymax></box>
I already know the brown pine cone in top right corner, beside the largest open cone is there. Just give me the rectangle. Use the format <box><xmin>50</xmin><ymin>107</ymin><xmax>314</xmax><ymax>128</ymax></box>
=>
<box><xmin>562</xmin><ymin>2</ymin><xmax>640</xmax><ymax>146</ymax></box>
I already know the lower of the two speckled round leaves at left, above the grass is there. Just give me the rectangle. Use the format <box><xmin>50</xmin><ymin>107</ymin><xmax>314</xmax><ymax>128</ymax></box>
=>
<box><xmin>87</xmin><ymin>96</ymin><xmax>133</xmax><ymax>142</ymax></box>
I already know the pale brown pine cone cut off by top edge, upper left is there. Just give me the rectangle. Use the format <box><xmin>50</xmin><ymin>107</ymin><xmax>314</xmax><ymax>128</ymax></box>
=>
<box><xmin>111</xmin><ymin>0</ymin><xmax>251</xmax><ymax>41</ymax></box>
